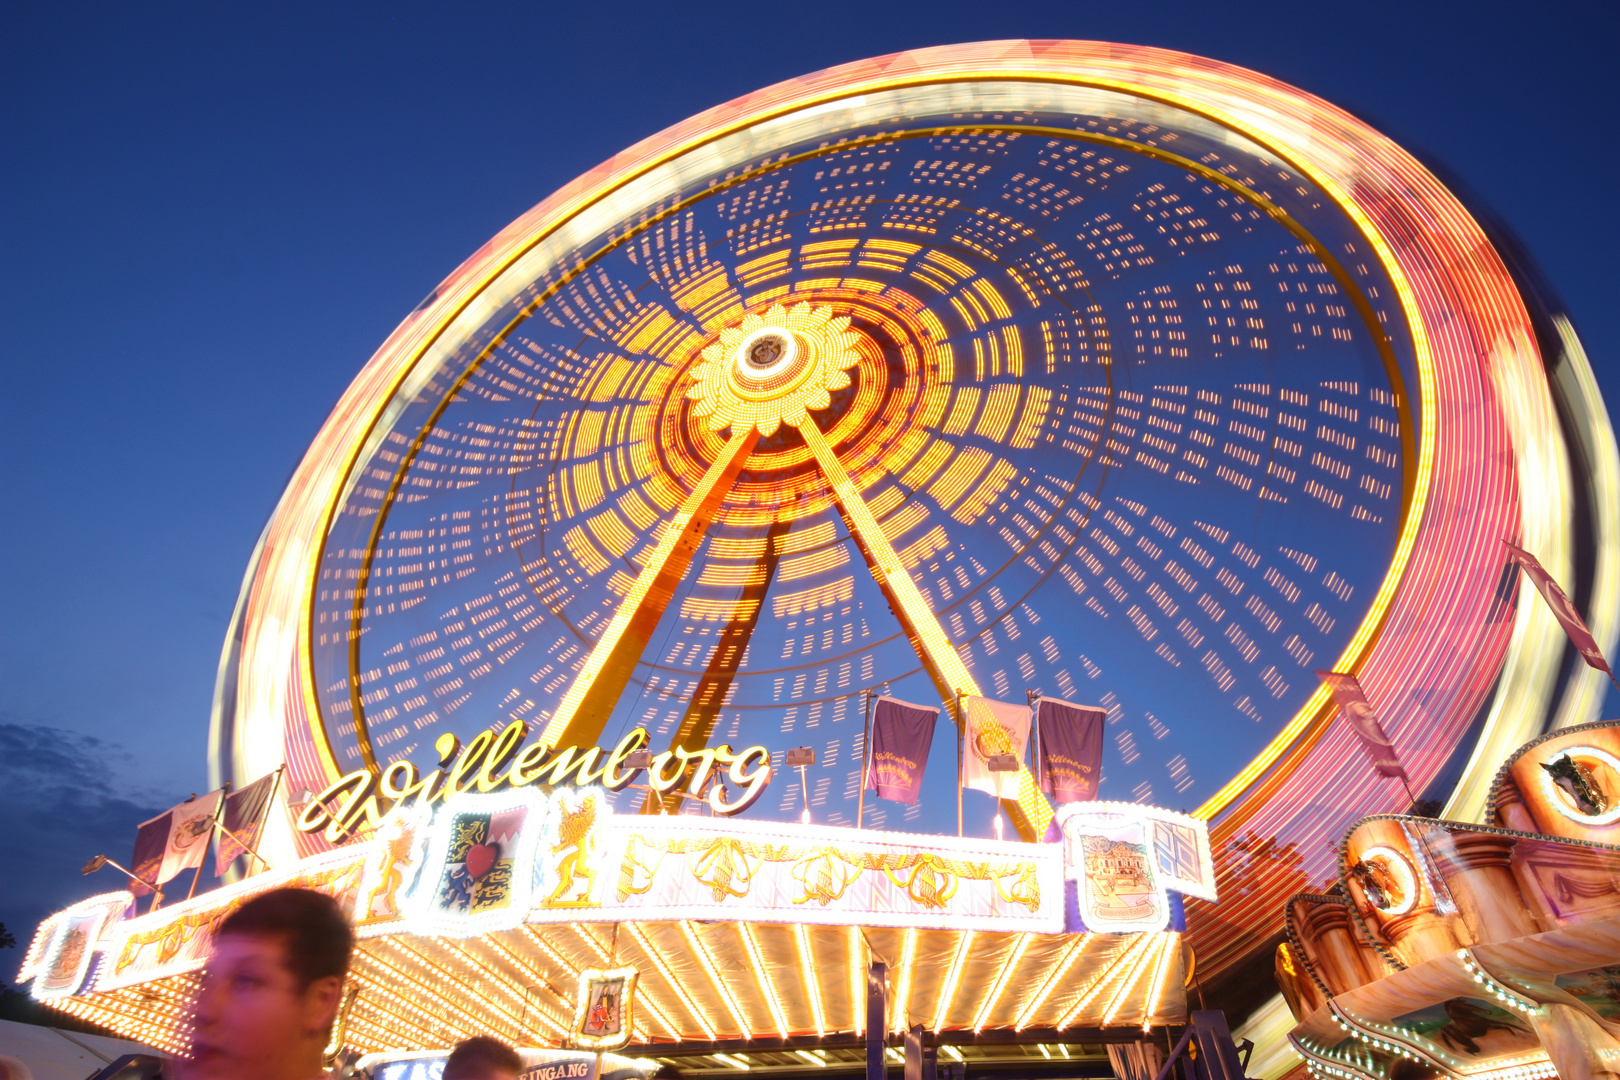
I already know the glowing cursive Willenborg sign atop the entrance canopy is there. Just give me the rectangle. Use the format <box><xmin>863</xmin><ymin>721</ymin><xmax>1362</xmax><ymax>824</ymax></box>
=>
<box><xmin>298</xmin><ymin>721</ymin><xmax>771</xmax><ymax>844</ymax></box>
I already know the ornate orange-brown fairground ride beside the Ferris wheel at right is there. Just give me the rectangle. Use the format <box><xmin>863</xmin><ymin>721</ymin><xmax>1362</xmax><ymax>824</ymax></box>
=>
<box><xmin>1277</xmin><ymin>721</ymin><xmax>1620</xmax><ymax>1080</ymax></box>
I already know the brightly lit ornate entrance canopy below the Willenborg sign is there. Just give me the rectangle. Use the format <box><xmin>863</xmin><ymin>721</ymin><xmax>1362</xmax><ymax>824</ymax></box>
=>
<box><xmin>19</xmin><ymin>789</ymin><xmax>1213</xmax><ymax>1051</ymax></box>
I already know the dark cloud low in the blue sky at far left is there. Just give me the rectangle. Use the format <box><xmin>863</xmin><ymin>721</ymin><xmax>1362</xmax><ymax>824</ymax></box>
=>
<box><xmin>0</xmin><ymin>721</ymin><xmax>166</xmax><ymax>952</ymax></box>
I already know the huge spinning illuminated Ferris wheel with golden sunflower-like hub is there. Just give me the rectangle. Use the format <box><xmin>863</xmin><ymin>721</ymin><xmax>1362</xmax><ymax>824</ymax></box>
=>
<box><xmin>214</xmin><ymin>42</ymin><xmax>1600</xmax><ymax>984</ymax></box>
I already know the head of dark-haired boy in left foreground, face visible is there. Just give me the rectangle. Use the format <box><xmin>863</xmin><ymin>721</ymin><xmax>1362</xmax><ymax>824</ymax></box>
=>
<box><xmin>188</xmin><ymin>889</ymin><xmax>355</xmax><ymax>1080</ymax></box>
